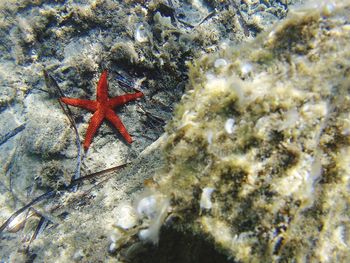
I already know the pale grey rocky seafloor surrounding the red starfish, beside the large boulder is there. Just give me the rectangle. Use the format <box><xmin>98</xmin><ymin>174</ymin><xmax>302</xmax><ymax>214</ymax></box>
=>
<box><xmin>0</xmin><ymin>0</ymin><xmax>349</xmax><ymax>262</ymax></box>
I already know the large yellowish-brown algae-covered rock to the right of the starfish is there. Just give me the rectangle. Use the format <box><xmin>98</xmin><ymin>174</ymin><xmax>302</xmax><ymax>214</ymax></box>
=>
<box><xmin>155</xmin><ymin>1</ymin><xmax>350</xmax><ymax>262</ymax></box>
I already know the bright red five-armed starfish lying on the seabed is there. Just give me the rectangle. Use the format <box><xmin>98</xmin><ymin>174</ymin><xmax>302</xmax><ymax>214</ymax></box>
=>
<box><xmin>61</xmin><ymin>70</ymin><xmax>143</xmax><ymax>151</ymax></box>
